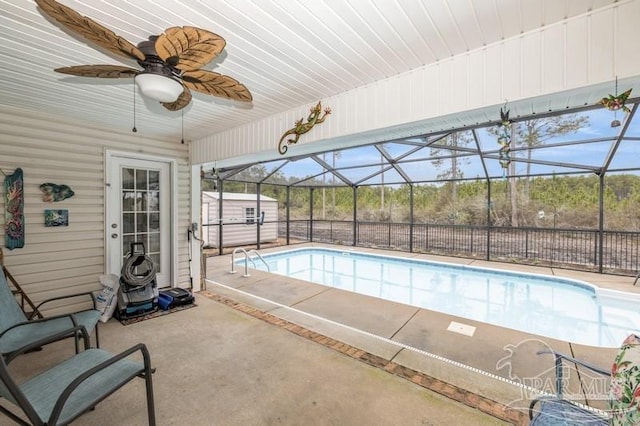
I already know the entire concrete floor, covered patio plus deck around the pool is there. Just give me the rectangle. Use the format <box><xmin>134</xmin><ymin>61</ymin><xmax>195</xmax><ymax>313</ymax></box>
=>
<box><xmin>0</xmin><ymin>244</ymin><xmax>638</xmax><ymax>426</ymax></box>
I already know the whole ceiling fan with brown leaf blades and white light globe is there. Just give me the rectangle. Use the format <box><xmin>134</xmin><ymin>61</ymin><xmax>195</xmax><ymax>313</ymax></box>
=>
<box><xmin>35</xmin><ymin>0</ymin><xmax>253</xmax><ymax>111</ymax></box>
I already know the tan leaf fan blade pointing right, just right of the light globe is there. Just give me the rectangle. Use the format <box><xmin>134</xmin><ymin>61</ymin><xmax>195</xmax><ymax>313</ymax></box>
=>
<box><xmin>182</xmin><ymin>70</ymin><xmax>253</xmax><ymax>102</ymax></box>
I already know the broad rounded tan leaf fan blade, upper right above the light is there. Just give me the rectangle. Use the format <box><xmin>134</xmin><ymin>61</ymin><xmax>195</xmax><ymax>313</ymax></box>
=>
<box><xmin>155</xmin><ymin>27</ymin><xmax>226</xmax><ymax>71</ymax></box>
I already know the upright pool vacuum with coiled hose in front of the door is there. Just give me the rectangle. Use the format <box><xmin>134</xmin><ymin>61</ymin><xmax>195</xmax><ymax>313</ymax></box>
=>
<box><xmin>115</xmin><ymin>243</ymin><xmax>158</xmax><ymax>319</ymax></box>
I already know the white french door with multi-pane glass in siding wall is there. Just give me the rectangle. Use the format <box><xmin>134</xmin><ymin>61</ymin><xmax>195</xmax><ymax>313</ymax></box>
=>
<box><xmin>106</xmin><ymin>155</ymin><xmax>173</xmax><ymax>287</ymax></box>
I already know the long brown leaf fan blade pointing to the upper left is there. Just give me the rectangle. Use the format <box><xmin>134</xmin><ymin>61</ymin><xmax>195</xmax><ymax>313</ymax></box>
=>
<box><xmin>36</xmin><ymin>0</ymin><xmax>144</xmax><ymax>61</ymax></box>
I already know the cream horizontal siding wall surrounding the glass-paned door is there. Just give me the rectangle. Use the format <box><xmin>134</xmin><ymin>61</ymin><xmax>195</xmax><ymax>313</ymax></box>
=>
<box><xmin>0</xmin><ymin>107</ymin><xmax>190</xmax><ymax>311</ymax></box>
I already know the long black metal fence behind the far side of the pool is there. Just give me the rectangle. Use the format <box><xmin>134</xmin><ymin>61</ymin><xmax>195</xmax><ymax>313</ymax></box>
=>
<box><xmin>278</xmin><ymin>220</ymin><xmax>640</xmax><ymax>275</ymax></box>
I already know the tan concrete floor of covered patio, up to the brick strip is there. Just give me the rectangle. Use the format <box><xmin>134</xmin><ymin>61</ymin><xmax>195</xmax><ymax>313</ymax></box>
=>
<box><xmin>0</xmin><ymin>288</ymin><xmax>503</xmax><ymax>426</ymax></box>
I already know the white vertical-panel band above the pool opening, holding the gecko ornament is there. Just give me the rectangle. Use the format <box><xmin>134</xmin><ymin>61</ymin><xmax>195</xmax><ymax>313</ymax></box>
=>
<box><xmin>191</xmin><ymin>0</ymin><xmax>640</xmax><ymax>164</ymax></box>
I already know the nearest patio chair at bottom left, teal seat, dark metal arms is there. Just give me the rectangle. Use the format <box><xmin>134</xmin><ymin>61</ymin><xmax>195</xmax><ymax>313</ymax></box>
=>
<box><xmin>0</xmin><ymin>326</ymin><xmax>155</xmax><ymax>426</ymax></box>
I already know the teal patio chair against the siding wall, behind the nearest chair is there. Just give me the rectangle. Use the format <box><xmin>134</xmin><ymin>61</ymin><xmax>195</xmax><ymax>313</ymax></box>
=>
<box><xmin>0</xmin><ymin>268</ymin><xmax>100</xmax><ymax>363</ymax></box>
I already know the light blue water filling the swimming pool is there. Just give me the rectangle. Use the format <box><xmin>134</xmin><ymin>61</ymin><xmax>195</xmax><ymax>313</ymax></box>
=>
<box><xmin>248</xmin><ymin>248</ymin><xmax>640</xmax><ymax>347</ymax></box>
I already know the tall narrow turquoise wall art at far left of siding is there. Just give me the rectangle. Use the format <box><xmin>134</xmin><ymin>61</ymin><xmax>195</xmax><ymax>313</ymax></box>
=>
<box><xmin>4</xmin><ymin>168</ymin><xmax>24</xmax><ymax>250</ymax></box>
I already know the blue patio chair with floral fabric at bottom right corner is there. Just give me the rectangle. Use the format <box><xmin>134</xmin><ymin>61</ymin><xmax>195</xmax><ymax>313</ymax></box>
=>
<box><xmin>529</xmin><ymin>334</ymin><xmax>640</xmax><ymax>426</ymax></box>
